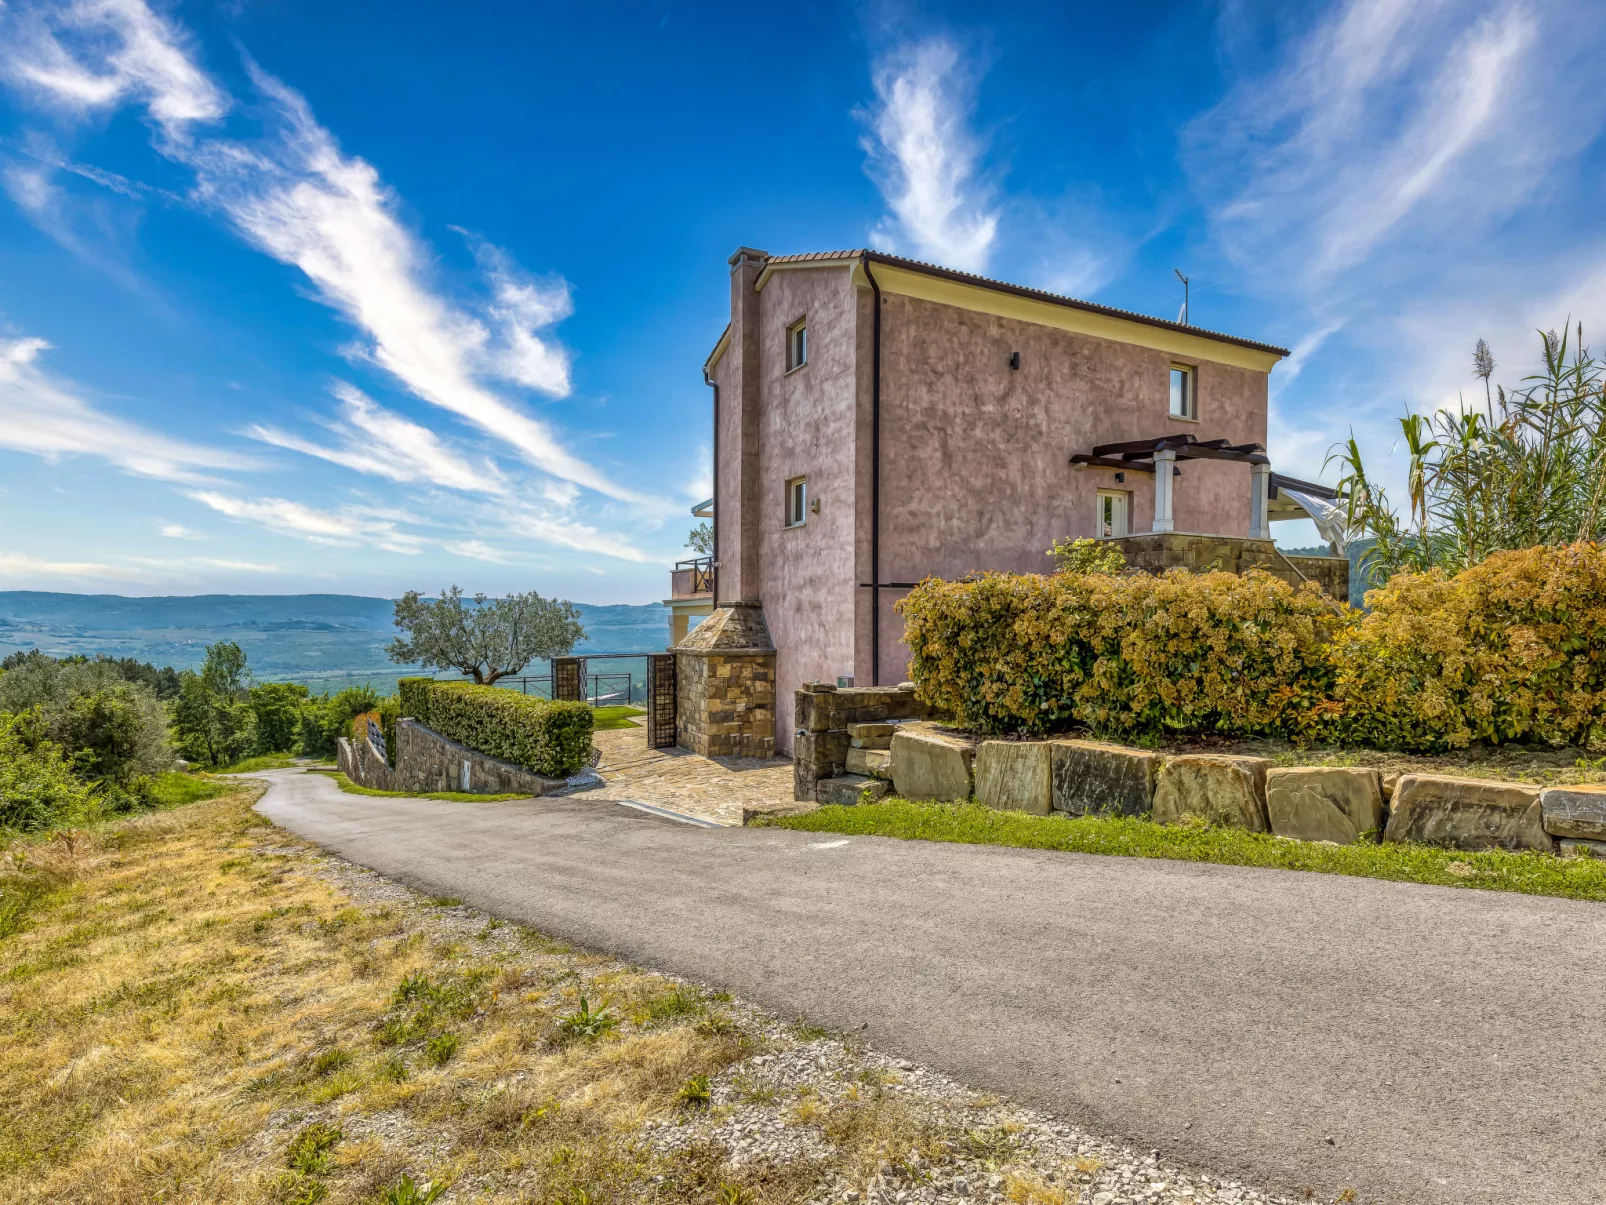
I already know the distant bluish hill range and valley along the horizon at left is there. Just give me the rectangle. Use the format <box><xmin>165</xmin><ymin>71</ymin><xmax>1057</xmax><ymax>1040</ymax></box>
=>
<box><xmin>0</xmin><ymin>590</ymin><xmax>670</xmax><ymax>691</ymax></box>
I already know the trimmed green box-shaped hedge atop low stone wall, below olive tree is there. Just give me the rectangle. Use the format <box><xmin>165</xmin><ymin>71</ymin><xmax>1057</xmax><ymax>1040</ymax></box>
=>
<box><xmin>417</xmin><ymin>678</ymin><xmax>591</xmax><ymax>778</ymax></box>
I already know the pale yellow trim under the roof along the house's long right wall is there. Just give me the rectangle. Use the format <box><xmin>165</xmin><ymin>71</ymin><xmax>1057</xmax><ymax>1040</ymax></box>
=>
<box><xmin>860</xmin><ymin>262</ymin><xmax>1282</xmax><ymax>373</ymax></box>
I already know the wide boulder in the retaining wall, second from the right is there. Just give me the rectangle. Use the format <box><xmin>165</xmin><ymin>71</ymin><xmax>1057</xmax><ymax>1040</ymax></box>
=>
<box><xmin>1383</xmin><ymin>774</ymin><xmax>1555</xmax><ymax>853</ymax></box>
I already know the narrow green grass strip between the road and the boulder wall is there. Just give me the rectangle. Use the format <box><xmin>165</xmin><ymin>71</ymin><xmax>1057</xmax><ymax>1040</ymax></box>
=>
<box><xmin>761</xmin><ymin>799</ymin><xmax>1606</xmax><ymax>901</ymax></box>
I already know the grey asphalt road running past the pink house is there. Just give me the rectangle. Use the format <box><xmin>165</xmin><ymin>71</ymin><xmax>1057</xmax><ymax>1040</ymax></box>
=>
<box><xmin>259</xmin><ymin>771</ymin><xmax>1606</xmax><ymax>1205</ymax></box>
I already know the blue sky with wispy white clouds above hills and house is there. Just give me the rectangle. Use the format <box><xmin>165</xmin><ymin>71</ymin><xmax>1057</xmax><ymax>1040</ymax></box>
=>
<box><xmin>0</xmin><ymin>0</ymin><xmax>1606</xmax><ymax>603</ymax></box>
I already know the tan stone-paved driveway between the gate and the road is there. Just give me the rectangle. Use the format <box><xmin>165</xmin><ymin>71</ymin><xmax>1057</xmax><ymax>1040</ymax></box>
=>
<box><xmin>575</xmin><ymin>728</ymin><xmax>814</xmax><ymax>826</ymax></box>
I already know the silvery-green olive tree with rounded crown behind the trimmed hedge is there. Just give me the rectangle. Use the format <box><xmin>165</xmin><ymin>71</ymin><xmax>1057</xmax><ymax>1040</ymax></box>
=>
<box><xmin>389</xmin><ymin>586</ymin><xmax>586</xmax><ymax>686</ymax></box>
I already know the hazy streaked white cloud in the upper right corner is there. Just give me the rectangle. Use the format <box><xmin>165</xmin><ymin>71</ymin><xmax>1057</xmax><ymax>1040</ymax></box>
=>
<box><xmin>1185</xmin><ymin>0</ymin><xmax>1580</xmax><ymax>291</ymax></box>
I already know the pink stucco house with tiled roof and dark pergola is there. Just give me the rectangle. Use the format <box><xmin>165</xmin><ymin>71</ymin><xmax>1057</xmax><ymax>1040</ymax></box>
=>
<box><xmin>676</xmin><ymin>247</ymin><xmax>1331</xmax><ymax>752</ymax></box>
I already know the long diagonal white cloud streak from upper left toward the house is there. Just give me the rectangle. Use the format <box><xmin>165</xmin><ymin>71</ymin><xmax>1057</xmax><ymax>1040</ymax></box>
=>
<box><xmin>0</xmin><ymin>0</ymin><xmax>650</xmax><ymax>520</ymax></box>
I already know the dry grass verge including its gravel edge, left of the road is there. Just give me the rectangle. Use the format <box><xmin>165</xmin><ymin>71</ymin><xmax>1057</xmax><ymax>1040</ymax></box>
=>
<box><xmin>0</xmin><ymin>779</ymin><xmax>1267</xmax><ymax>1205</ymax></box>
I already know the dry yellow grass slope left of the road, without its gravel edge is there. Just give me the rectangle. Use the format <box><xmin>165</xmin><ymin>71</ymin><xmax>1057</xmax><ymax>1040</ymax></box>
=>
<box><xmin>0</xmin><ymin>784</ymin><xmax>785</xmax><ymax>1205</ymax></box>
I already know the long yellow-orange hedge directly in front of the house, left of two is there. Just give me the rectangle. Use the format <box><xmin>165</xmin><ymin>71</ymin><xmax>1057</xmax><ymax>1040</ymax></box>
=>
<box><xmin>899</xmin><ymin>570</ymin><xmax>1346</xmax><ymax>739</ymax></box>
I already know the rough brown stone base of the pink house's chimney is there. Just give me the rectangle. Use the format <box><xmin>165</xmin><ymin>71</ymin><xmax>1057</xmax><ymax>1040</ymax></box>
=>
<box><xmin>675</xmin><ymin>603</ymin><xmax>776</xmax><ymax>757</ymax></box>
